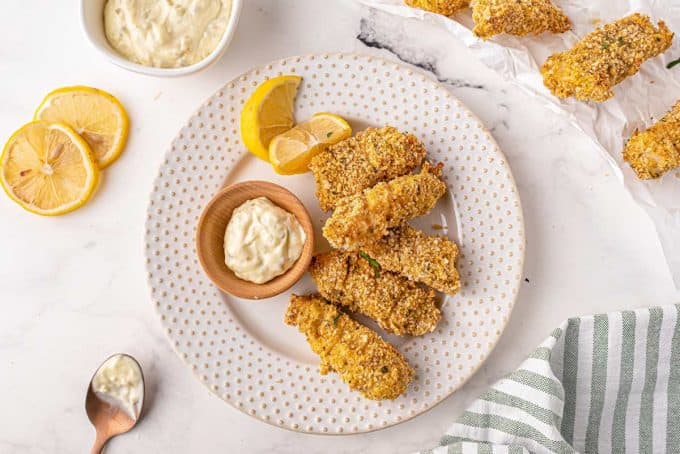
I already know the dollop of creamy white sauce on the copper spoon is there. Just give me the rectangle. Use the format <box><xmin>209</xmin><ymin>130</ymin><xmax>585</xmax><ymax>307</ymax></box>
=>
<box><xmin>92</xmin><ymin>355</ymin><xmax>144</xmax><ymax>419</ymax></box>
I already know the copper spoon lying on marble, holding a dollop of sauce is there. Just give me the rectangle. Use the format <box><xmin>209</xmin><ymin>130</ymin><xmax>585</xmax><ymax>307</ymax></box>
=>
<box><xmin>85</xmin><ymin>354</ymin><xmax>144</xmax><ymax>454</ymax></box>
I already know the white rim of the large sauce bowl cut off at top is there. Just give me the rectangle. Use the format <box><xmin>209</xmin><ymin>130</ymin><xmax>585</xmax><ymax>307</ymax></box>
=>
<box><xmin>80</xmin><ymin>0</ymin><xmax>243</xmax><ymax>77</ymax></box>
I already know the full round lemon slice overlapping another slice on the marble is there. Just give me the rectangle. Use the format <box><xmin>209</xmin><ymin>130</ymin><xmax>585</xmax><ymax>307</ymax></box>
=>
<box><xmin>0</xmin><ymin>122</ymin><xmax>99</xmax><ymax>216</ymax></box>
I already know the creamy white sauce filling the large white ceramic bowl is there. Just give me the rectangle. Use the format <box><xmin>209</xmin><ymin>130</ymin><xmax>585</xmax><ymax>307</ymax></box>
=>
<box><xmin>104</xmin><ymin>0</ymin><xmax>231</xmax><ymax>68</ymax></box>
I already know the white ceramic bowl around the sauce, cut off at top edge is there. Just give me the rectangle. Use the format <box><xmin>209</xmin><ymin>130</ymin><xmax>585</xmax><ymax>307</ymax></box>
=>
<box><xmin>80</xmin><ymin>0</ymin><xmax>242</xmax><ymax>77</ymax></box>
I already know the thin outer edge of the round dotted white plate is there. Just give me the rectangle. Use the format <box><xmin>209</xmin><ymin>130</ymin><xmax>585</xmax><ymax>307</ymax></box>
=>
<box><xmin>143</xmin><ymin>52</ymin><xmax>526</xmax><ymax>437</ymax></box>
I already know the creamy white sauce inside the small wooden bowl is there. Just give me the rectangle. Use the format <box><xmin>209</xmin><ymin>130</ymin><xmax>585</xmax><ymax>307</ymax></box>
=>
<box><xmin>224</xmin><ymin>197</ymin><xmax>306</xmax><ymax>284</ymax></box>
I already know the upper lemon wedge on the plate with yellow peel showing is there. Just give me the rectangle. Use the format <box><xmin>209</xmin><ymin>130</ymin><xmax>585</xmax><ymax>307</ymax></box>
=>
<box><xmin>241</xmin><ymin>76</ymin><xmax>302</xmax><ymax>161</ymax></box>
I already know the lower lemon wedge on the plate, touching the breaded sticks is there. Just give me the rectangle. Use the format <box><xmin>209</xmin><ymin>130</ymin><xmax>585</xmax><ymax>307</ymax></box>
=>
<box><xmin>269</xmin><ymin>112</ymin><xmax>352</xmax><ymax>175</ymax></box>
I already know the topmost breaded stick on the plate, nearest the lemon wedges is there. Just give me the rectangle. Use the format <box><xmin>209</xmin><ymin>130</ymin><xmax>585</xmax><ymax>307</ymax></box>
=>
<box><xmin>309</xmin><ymin>126</ymin><xmax>426</xmax><ymax>211</ymax></box>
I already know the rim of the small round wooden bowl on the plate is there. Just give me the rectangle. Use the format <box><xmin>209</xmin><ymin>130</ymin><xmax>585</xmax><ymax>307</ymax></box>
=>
<box><xmin>194</xmin><ymin>180</ymin><xmax>315</xmax><ymax>300</ymax></box>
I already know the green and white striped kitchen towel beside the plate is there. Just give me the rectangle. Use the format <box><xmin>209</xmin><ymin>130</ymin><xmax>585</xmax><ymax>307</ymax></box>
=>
<box><xmin>425</xmin><ymin>305</ymin><xmax>680</xmax><ymax>454</ymax></box>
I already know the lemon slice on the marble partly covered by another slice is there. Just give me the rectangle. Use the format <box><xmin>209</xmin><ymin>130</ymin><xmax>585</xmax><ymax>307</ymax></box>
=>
<box><xmin>34</xmin><ymin>86</ymin><xmax>129</xmax><ymax>169</ymax></box>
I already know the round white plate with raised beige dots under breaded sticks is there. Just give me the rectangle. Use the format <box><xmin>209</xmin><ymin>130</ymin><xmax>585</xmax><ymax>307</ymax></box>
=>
<box><xmin>146</xmin><ymin>54</ymin><xmax>524</xmax><ymax>434</ymax></box>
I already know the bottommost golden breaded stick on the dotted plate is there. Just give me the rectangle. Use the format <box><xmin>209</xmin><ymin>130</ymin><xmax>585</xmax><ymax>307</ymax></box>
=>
<box><xmin>284</xmin><ymin>295</ymin><xmax>413</xmax><ymax>400</ymax></box>
